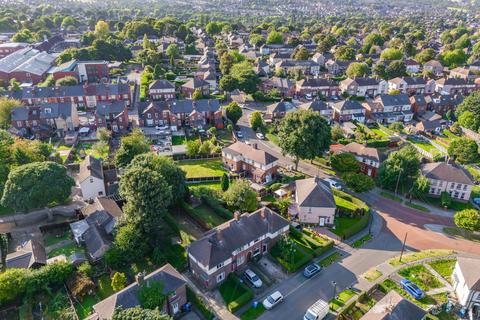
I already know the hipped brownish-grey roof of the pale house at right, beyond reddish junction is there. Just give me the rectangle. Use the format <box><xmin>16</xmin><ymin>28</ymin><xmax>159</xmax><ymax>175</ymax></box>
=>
<box><xmin>421</xmin><ymin>162</ymin><xmax>473</xmax><ymax>185</ymax></box>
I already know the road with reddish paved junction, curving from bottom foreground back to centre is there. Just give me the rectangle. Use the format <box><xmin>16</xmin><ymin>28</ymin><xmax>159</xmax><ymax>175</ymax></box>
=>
<box><xmin>238</xmin><ymin>109</ymin><xmax>480</xmax><ymax>320</ymax></box>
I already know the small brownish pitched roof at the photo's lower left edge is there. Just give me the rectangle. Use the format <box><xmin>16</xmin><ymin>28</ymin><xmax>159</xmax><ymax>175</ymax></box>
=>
<box><xmin>6</xmin><ymin>239</ymin><xmax>47</xmax><ymax>269</ymax></box>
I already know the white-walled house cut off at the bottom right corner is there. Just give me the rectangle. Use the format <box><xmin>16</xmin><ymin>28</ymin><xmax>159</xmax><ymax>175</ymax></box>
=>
<box><xmin>452</xmin><ymin>257</ymin><xmax>480</xmax><ymax>320</ymax></box>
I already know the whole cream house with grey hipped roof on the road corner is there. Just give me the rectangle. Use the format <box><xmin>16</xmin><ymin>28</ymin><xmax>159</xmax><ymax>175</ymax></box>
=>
<box><xmin>288</xmin><ymin>177</ymin><xmax>337</xmax><ymax>226</ymax></box>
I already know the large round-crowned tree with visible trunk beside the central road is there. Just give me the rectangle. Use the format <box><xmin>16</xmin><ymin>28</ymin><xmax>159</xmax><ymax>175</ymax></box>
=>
<box><xmin>278</xmin><ymin>110</ymin><xmax>331</xmax><ymax>169</ymax></box>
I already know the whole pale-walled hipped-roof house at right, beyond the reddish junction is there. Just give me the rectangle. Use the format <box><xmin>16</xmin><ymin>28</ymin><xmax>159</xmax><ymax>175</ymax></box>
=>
<box><xmin>421</xmin><ymin>162</ymin><xmax>474</xmax><ymax>202</ymax></box>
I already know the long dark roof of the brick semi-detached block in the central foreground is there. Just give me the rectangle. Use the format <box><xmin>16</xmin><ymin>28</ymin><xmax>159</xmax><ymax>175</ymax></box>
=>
<box><xmin>188</xmin><ymin>207</ymin><xmax>288</xmax><ymax>268</ymax></box>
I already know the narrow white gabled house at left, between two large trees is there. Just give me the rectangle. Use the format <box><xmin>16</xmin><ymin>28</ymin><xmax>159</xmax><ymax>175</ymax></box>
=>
<box><xmin>78</xmin><ymin>156</ymin><xmax>106</xmax><ymax>201</ymax></box>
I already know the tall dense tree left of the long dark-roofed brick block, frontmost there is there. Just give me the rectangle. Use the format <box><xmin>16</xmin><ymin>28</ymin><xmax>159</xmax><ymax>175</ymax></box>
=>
<box><xmin>120</xmin><ymin>165</ymin><xmax>172</xmax><ymax>236</ymax></box>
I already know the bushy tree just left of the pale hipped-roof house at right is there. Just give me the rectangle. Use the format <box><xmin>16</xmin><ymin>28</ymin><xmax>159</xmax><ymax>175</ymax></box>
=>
<box><xmin>377</xmin><ymin>146</ymin><xmax>420</xmax><ymax>190</ymax></box>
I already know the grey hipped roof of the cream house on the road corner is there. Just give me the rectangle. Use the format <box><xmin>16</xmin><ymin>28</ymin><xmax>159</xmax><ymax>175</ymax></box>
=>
<box><xmin>295</xmin><ymin>178</ymin><xmax>337</xmax><ymax>208</ymax></box>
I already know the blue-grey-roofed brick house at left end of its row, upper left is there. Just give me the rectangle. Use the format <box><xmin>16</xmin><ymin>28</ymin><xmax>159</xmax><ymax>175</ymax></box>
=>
<box><xmin>95</xmin><ymin>101</ymin><xmax>129</xmax><ymax>133</ymax></box>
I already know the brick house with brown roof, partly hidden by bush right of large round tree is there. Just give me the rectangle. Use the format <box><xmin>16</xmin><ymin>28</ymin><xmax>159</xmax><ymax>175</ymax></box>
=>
<box><xmin>335</xmin><ymin>142</ymin><xmax>380</xmax><ymax>178</ymax></box>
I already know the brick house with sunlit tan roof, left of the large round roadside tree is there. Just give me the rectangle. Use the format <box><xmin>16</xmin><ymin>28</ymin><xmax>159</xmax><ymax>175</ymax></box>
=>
<box><xmin>222</xmin><ymin>141</ymin><xmax>278</xmax><ymax>183</ymax></box>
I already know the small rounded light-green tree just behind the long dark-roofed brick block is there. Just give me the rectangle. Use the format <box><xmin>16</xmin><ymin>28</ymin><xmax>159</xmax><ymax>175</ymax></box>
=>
<box><xmin>223</xmin><ymin>180</ymin><xmax>258</xmax><ymax>212</ymax></box>
